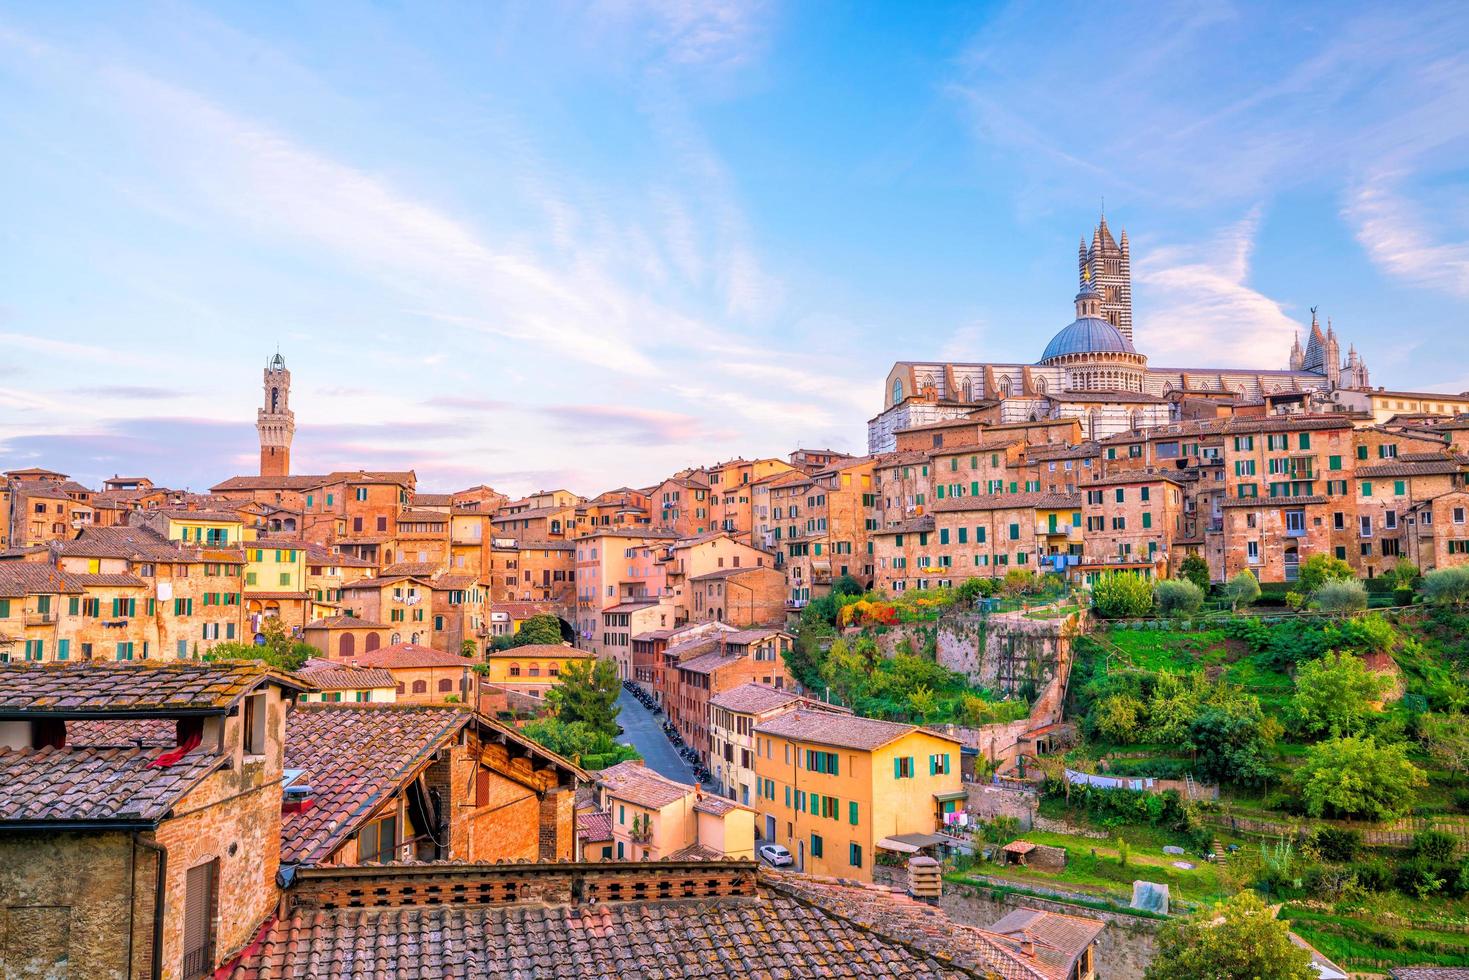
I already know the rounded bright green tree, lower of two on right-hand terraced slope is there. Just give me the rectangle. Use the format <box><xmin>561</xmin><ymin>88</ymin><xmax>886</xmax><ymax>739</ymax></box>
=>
<box><xmin>1293</xmin><ymin>736</ymin><xmax>1428</xmax><ymax>820</ymax></box>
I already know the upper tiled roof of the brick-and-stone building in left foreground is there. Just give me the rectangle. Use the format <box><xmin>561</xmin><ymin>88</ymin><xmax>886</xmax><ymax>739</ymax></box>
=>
<box><xmin>0</xmin><ymin>661</ymin><xmax>311</xmax><ymax>717</ymax></box>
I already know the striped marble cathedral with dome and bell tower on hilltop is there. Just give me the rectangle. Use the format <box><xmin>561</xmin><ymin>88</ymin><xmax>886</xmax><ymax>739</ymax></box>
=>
<box><xmin>867</xmin><ymin>217</ymin><xmax>1368</xmax><ymax>454</ymax></box>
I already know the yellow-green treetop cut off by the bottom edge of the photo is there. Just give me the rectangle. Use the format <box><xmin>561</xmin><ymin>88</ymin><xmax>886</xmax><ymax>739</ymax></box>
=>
<box><xmin>1143</xmin><ymin>892</ymin><xmax>1316</xmax><ymax>980</ymax></box>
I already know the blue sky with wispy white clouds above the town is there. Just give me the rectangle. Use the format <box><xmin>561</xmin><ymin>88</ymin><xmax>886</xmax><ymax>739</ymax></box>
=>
<box><xmin>0</xmin><ymin>0</ymin><xmax>1469</xmax><ymax>494</ymax></box>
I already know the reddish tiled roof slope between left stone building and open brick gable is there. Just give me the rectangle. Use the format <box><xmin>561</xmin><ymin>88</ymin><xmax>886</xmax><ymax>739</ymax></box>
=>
<box><xmin>281</xmin><ymin>702</ymin><xmax>472</xmax><ymax>864</ymax></box>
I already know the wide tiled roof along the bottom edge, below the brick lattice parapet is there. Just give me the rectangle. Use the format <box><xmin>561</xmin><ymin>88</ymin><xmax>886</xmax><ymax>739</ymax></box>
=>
<box><xmin>234</xmin><ymin>864</ymin><xmax>1046</xmax><ymax>980</ymax></box>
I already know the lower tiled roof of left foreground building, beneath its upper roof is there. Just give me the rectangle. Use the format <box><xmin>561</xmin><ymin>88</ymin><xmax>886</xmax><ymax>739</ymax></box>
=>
<box><xmin>0</xmin><ymin>748</ymin><xmax>225</xmax><ymax>824</ymax></box>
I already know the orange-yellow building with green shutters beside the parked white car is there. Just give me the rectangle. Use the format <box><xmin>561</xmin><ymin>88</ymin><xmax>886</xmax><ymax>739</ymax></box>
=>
<box><xmin>755</xmin><ymin>710</ymin><xmax>964</xmax><ymax>882</ymax></box>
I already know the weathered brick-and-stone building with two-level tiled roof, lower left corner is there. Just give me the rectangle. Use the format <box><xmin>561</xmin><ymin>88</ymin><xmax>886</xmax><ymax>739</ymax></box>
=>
<box><xmin>0</xmin><ymin>663</ymin><xmax>306</xmax><ymax>977</ymax></box>
